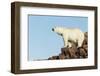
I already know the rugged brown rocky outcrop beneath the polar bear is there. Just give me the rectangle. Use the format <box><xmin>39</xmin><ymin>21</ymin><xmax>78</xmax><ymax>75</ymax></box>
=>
<box><xmin>48</xmin><ymin>32</ymin><xmax>88</xmax><ymax>60</ymax></box>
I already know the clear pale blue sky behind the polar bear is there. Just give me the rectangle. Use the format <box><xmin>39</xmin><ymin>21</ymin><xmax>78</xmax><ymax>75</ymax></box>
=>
<box><xmin>28</xmin><ymin>15</ymin><xmax>88</xmax><ymax>60</ymax></box>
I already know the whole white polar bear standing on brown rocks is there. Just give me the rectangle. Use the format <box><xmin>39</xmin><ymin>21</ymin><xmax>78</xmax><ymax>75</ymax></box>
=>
<box><xmin>52</xmin><ymin>27</ymin><xmax>84</xmax><ymax>47</ymax></box>
